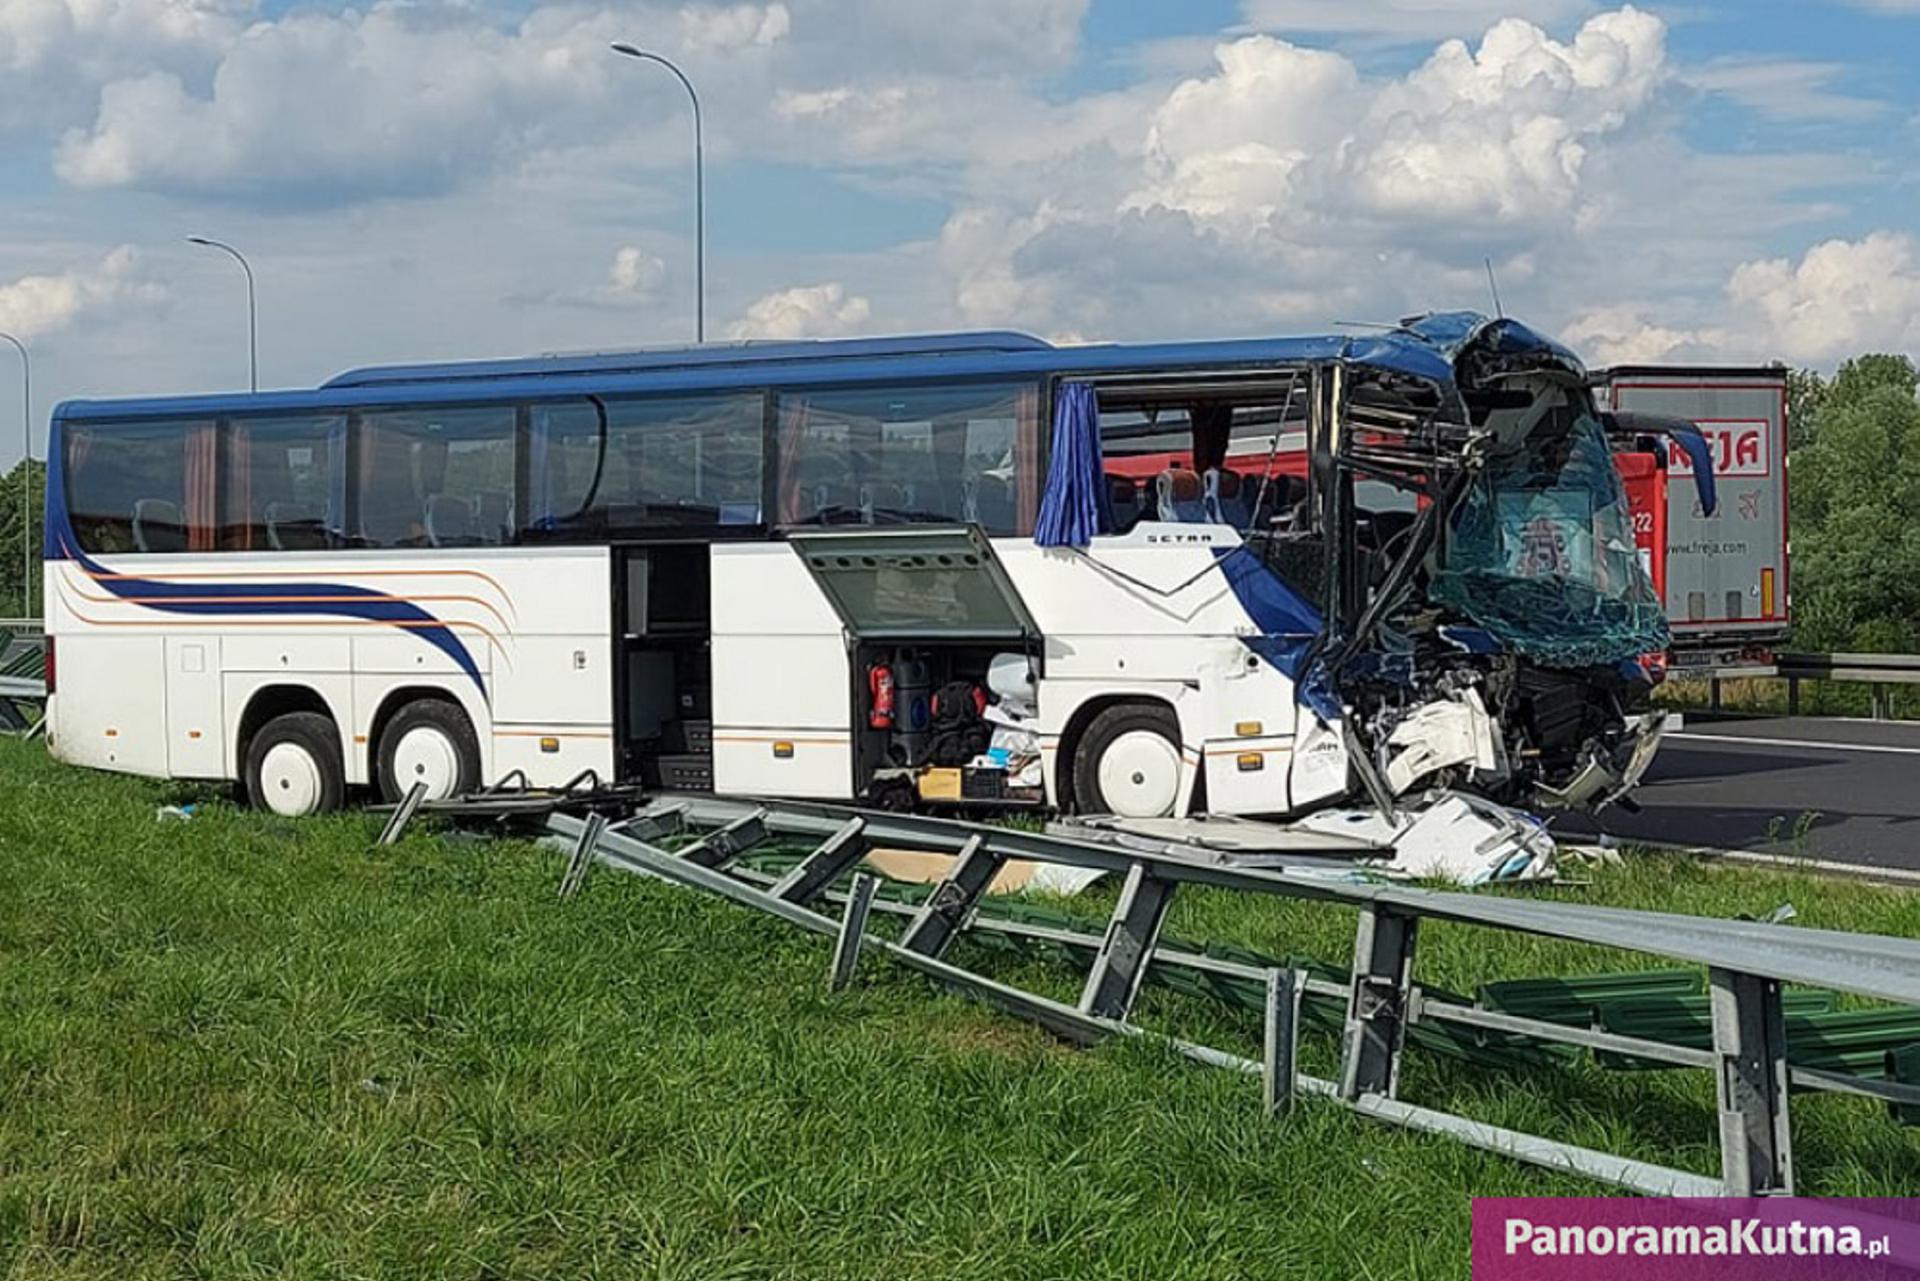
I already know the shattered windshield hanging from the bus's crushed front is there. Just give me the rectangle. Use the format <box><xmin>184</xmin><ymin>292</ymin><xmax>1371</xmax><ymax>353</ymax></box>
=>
<box><xmin>1432</xmin><ymin>388</ymin><xmax>1668</xmax><ymax>666</ymax></box>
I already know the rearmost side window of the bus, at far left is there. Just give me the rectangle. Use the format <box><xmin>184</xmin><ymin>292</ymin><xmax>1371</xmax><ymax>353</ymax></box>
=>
<box><xmin>63</xmin><ymin>421</ymin><xmax>217</xmax><ymax>551</ymax></box>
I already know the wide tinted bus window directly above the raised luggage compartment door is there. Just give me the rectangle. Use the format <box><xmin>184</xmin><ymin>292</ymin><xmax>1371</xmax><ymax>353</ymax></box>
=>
<box><xmin>778</xmin><ymin>384</ymin><xmax>1041</xmax><ymax>534</ymax></box>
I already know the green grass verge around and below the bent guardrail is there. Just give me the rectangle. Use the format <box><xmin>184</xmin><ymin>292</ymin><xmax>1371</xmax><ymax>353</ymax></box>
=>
<box><xmin>0</xmin><ymin>741</ymin><xmax>1920</xmax><ymax>1281</ymax></box>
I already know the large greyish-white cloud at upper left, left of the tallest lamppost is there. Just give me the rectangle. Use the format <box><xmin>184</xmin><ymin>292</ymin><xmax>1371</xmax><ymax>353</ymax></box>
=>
<box><xmin>56</xmin><ymin>2</ymin><xmax>625</xmax><ymax>202</ymax></box>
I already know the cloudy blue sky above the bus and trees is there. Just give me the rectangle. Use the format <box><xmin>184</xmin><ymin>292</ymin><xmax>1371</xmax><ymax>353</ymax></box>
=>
<box><xmin>0</xmin><ymin>0</ymin><xmax>1920</xmax><ymax>461</ymax></box>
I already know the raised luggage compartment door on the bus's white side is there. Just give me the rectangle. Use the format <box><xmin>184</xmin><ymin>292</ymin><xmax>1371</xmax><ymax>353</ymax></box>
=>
<box><xmin>791</xmin><ymin>526</ymin><xmax>1039</xmax><ymax>647</ymax></box>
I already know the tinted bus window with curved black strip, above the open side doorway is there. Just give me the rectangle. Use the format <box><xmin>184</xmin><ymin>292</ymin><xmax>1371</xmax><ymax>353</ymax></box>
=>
<box><xmin>528</xmin><ymin>392</ymin><xmax>766</xmax><ymax>530</ymax></box>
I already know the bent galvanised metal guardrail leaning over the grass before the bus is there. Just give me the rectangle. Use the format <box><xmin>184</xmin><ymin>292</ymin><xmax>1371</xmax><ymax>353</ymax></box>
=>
<box><xmin>549</xmin><ymin>797</ymin><xmax>1920</xmax><ymax>1196</ymax></box>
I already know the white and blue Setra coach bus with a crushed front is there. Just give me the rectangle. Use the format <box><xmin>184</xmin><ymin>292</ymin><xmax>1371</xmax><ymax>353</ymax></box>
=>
<box><xmin>46</xmin><ymin>313</ymin><xmax>1665</xmax><ymax>816</ymax></box>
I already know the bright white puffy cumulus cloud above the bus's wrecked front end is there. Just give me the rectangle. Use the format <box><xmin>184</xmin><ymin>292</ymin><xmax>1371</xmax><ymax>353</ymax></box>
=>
<box><xmin>1127</xmin><ymin>6</ymin><xmax>1668</xmax><ymax>230</ymax></box>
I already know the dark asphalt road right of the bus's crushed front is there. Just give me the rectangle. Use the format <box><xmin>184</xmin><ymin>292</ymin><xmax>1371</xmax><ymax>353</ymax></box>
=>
<box><xmin>1553</xmin><ymin>713</ymin><xmax>1920</xmax><ymax>872</ymax></box>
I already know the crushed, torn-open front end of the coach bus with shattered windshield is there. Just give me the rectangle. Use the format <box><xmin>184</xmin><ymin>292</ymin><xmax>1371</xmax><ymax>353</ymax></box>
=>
<box><xmin>1250</xmin><ymin>313</ymin><xmax>1667</xmax><ymax>814</ymax></box>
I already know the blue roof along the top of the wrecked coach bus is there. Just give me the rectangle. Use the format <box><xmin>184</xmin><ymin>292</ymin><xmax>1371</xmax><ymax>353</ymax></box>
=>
<box><xmin>54</xmin><ymin>311</ymin><xmax>1572</xmax><ymax>419</ymax></box>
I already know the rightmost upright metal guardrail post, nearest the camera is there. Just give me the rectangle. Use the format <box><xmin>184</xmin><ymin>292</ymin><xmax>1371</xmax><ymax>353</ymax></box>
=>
<box><xmin>1707</xmin><ymin>968</ymin><xmax>1793</xmax><ymax>1196</ymax></box>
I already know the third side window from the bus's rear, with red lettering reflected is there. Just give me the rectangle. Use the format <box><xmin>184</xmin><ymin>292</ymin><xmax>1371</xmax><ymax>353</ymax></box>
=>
<box><xmin>353</xmin><ymin>405</ymin><xmax>515</xmax><ymax>547</ymax></box>
